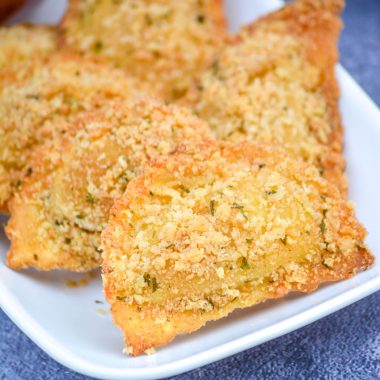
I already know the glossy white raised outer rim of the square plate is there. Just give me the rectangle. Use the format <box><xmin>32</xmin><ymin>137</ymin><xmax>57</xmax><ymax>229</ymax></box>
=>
<box><xmin>0</xmin><ymin>64</ymin><xmax>380</xmax><ymax>380</ymax></box>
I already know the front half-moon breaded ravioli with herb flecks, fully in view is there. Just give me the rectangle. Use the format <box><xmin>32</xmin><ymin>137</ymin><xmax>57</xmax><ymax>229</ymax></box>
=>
<box><xmin>102</xmin><ymin>143</ymin><xmax>373</xmax><ymax>355</ymax></box>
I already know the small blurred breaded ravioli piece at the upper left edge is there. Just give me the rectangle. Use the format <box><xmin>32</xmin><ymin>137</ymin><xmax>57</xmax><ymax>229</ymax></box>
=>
<box><xmin>0</xmin><ymin>25</ymin><xmax>57</xmax><ymax>69</ymax></box>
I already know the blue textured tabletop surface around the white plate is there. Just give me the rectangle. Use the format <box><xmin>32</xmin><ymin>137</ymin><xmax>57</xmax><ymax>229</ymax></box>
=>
<box><xmin>0</xmin><ymin>0</ymin><xmax>380</xmax><ymax>380</ymax></box>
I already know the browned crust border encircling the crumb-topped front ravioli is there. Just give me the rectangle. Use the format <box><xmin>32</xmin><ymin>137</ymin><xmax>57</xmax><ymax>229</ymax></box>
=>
<box><xmin>102</xmin><ymin>142</ymin><xmax>374</xmax><ymax>355</ymax></box>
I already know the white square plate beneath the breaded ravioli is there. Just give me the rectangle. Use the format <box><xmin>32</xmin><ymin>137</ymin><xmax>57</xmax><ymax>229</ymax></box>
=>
<box><xmin>0</xmin><ymin>0</ymin><xmax>380</xmax><ymax>379</ymax></box>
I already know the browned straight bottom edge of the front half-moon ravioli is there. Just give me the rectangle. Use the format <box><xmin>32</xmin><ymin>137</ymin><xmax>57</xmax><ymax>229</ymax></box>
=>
<box><xmin>108</xmin><ymin>239</ymin><xmax>374</xmax><ymax>356</ymax></box>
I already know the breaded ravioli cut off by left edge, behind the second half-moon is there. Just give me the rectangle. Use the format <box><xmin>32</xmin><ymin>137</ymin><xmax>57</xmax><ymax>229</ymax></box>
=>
<box><xmin>0</xmin><ymin>54</ymin><xmax>138</xmax><ymax>210</ymax></box>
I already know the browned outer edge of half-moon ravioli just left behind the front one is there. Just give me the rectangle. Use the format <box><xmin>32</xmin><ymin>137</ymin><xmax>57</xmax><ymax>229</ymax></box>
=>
<box><xmin>5</xmin><ymin>98</ymin><xmax>214</xmax><ymax>272</ymax></box>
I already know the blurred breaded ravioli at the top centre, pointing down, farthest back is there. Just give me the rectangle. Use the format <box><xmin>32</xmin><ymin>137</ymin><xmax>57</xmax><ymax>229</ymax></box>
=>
<box><xmin>62</xmin><ymin>0</ymin><xmax>225</xmax><ymax>101</ymax></box>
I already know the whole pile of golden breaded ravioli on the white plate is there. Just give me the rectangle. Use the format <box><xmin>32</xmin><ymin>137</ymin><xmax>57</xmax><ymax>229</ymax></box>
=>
<box><xmin>0</xmin><ymin>0</ymin><xmax>374</xmax><ymax>355</ymax></box>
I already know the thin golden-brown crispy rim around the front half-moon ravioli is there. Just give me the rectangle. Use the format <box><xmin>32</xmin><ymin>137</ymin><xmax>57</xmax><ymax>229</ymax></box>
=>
<box><xmin>102</xmin><ymin>142</ymin><xmax>374</xmax><ymax>355</ymax></box>
